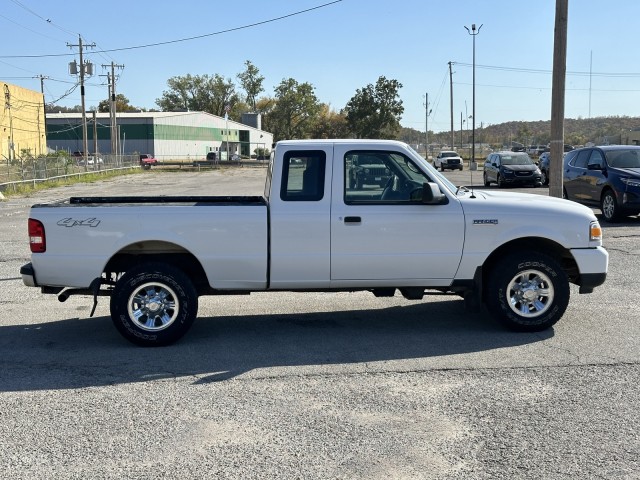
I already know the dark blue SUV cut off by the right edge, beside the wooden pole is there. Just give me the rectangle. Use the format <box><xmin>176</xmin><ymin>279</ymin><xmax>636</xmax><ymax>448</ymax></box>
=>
<box><xmin>562</xmin><ymin>145</ymin><xmax>640</xmax><ymax>222</ymax></box>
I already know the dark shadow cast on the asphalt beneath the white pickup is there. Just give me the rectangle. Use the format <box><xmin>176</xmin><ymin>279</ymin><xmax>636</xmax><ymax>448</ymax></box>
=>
<box><xmin>0</xmin><ymin>299</ymin><xmax>554</xmax><ymax>392</ymax></box>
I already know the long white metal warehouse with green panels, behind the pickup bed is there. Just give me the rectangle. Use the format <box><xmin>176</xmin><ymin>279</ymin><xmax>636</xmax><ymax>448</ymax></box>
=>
<box><xmin>47</xmin><ymin>112</ymin><xmax>273</xmax><ymax>160</ymax></box>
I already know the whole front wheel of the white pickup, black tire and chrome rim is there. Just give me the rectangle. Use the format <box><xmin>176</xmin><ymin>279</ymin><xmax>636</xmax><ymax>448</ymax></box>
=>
<box><xmin>485</xmin><ymin>252</ymin><xmax>570</xmax><ymax>332</ymax></box>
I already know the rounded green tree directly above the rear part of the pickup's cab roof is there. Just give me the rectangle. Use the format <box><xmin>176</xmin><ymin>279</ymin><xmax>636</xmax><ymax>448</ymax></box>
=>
<box><xmin>268</xmin><ymin>78</ymin><xmax>321</xmax><ymax>141</ymax></box>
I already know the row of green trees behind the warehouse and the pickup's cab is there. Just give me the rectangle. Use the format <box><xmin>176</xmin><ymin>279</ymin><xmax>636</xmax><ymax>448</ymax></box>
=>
<box><xmin>47</xmin><ymin>60</ymin><xmax>404</xmax><ymax>141</ymax></box>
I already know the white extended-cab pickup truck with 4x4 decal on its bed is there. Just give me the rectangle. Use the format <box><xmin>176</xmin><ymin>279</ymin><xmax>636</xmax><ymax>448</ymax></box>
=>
<box><xmin>20</xmin><ymin>140</ymin><xmax>608</xmax><ymax>345</ymax></box>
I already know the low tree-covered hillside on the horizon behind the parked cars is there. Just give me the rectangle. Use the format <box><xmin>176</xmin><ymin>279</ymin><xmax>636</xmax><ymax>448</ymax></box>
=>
<box><xmin>400</xmin><ymin>117</ymin><xmax>640</xmax><ymax>146</ymax></box>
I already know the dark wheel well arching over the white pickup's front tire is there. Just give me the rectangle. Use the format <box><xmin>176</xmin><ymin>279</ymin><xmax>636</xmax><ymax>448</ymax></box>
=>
<box><xmin>482</xmin><ymin>237</ymin><xmax>579</xmax><ymax>285</ymax></box>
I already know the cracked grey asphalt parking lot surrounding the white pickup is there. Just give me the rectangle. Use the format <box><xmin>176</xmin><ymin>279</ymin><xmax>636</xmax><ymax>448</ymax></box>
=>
<box><xmin>0</xmin><ymin>168</ymin><xmax>640</xmax><ymax>479</ymax></box>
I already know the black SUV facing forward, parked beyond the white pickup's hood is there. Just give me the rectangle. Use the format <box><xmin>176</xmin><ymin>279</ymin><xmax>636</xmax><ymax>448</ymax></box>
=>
<box><xmin>482</xmin><ymin>152</ymin><xmax>542</xmax><ymax>187</ymax></box>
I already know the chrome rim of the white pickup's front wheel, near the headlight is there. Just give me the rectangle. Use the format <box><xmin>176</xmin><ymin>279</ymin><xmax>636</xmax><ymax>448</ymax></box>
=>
<box><xmin>507</xmin><ymin>270</ymin><xmax>554</xmax><ymax>318</ymax></box>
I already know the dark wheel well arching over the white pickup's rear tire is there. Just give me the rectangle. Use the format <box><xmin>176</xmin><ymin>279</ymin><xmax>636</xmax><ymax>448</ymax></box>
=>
<box><xmin>104</xmin><ymin>242</ymin><xmax>209</xmax><ymax>294</ymax></box>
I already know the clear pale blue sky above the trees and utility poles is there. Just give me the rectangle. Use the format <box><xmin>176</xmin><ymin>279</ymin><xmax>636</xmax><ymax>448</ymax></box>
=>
<box><xmin>0</xmin><ymin>0</ymin><xmax>640</xmax><ymax>132</ymax></box>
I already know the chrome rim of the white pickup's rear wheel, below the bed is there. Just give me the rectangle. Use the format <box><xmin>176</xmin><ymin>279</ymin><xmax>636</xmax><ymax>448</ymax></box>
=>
<box><xmin>127</xmin><ymin>282</ymin><xmax>180</xmax><ymax>332</ymax></box>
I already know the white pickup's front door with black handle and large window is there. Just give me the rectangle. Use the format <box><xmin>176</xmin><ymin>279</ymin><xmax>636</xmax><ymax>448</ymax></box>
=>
<box><xmin>331</xmin><ymin>144</ymin><xmax>464</xmax><ymax>287</ymax></box>
